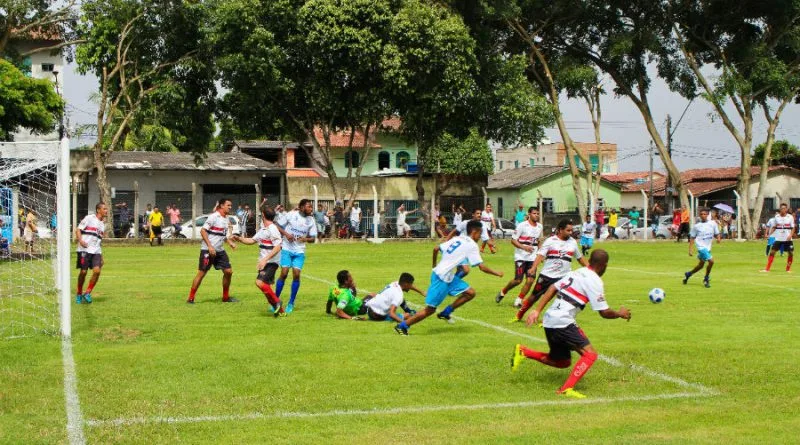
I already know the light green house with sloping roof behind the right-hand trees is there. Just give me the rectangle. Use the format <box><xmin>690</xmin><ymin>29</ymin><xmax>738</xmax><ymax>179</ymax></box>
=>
<box><xmin>486</xmin><ymin>165</ymin><xmax>621</xmax><ymax>218</ymax></box>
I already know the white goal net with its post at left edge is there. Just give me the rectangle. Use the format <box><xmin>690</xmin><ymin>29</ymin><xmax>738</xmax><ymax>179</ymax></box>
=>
<box><xmin>0</xmin><ymin>140</ymin><xmax>70</xmax><ymax>339</ymax></box>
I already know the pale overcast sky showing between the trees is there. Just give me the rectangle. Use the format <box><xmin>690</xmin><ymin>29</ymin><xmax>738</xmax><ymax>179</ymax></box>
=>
<box><xmin>64</xmin><ymin>60</ymin><xmax>800</xmax><ymax>171</ymax></box>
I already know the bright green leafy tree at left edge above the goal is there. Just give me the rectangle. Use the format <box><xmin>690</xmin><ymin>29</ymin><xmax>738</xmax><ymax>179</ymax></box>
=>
<box><xmin>0</xmin><ymin>59</ymin><xmax>64</xmax><ymax>141</ymax></box>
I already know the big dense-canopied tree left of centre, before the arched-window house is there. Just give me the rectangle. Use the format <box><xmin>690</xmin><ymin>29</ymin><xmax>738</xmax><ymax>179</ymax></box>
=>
<box><xmin>213</xmin><ymin>0</ymin><xmax>397</xmax><ymax>206</ymax></box>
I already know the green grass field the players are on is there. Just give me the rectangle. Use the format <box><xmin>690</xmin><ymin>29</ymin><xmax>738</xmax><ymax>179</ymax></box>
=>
<box><xmin>0</xmin><ymin>242</ymin><xmax>800</xmax><ymax>444</ymax></box>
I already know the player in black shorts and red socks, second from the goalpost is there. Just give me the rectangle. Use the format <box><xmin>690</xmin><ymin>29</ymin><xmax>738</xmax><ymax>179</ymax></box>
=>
<box><xmin>186</xmin><ymin>198</ymin><xmax>239</xmax><ymax>304</ymax></box>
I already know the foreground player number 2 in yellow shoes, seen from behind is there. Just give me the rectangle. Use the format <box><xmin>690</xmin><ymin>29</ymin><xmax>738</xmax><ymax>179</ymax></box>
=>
<box><xmin>511</xmin><ymin>249</ymin><xmax>631</xmax><ymax>399</ymax></box>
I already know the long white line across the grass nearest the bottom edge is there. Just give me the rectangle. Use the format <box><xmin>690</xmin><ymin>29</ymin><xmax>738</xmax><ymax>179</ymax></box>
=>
<box><xmin>86</xmin><ymin>392</ymin><xmax>712</xmax><ymax>427</ymax></box>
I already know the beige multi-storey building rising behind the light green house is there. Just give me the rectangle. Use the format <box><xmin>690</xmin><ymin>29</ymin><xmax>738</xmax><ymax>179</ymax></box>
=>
<box><xmin>495</xmin><ymin>142</ymin><xmax>618</xmax><ymax>174</ymax></box>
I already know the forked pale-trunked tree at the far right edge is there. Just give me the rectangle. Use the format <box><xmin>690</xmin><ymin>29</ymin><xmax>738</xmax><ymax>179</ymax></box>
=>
<box><xmin>670</xmin><ymin>0</ymin><xmax>800</xmax><ymax>236</ymax></box>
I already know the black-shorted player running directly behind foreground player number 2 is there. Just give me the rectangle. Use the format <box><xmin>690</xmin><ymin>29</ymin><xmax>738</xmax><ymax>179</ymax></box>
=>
<box><xmin>511</xmin><ymin>219</ymin><xmax>589</xmax><ymax>323</ymax></box>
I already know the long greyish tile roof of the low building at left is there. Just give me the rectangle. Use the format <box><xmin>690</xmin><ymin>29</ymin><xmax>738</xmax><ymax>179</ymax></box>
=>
<box><xmin>106</xmin><ymin>151</ymin><xmax>283</xmax><ymax>171</ymax></box>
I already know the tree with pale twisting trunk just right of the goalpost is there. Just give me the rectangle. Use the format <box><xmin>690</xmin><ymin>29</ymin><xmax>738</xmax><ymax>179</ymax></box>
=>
<box><xmin>77</xmin><ymin>0</ymin><xmax>211</xmax><ymax>229</ymax></box>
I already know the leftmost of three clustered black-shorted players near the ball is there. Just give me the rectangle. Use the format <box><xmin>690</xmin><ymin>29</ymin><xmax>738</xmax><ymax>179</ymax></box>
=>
<box><xmin>494</xmin><ymin>207</ymin><xmax>542</xmax><ymax>307</ymax></box>
